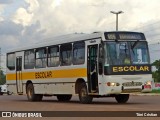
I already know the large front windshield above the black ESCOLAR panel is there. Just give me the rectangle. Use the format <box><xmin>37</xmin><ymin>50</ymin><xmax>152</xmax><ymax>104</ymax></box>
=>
<box><xmin>104</xmin><ymin>41</ymin><xmax>149</xmax><ymax>65</ymax></box>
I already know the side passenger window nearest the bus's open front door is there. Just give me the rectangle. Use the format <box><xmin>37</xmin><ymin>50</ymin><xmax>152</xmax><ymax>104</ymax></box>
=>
<box><xmin>73</xmin><ymin>42</ymin><xmax>85</xmax><ymax>65</ymax></box>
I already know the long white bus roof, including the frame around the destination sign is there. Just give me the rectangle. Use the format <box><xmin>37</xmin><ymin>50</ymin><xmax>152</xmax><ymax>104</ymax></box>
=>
<box><xmin>7</xmin><ymin>31</ymin><xmax>145</xmax><ymax>53</ymax></box>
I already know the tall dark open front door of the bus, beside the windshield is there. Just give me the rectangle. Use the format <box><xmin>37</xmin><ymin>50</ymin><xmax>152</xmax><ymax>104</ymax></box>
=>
<box><xmin>87</xmin><ymin>44</ymin><xmax>98</xmax><ymax>93</ymax></box>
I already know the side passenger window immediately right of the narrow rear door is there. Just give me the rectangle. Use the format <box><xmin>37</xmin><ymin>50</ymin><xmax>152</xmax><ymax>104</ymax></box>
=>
<box><xmin>24</xmin><ymin>49</ymin><xmax>35</xmax><ymax>69</ymax></box>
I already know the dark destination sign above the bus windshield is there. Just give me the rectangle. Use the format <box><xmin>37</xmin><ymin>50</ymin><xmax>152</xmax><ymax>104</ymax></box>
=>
<box><xmin>105</xmin><ymin>32</ymin><xmax>145</xmax><ymax>40</ymax></box>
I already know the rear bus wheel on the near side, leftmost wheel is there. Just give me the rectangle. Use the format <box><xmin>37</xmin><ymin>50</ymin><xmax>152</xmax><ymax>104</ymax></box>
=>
<box><xmin>27</xmin><ymin>83</ymin><xmax>43</xmax><ymax>101</ymax></box>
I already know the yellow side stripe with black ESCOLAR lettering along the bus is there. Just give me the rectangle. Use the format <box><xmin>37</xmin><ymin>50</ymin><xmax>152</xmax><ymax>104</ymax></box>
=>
<box><xmin>6</xmin><ymin>68</ymin><xmax>87</xmax><ymax>80</ymax></box>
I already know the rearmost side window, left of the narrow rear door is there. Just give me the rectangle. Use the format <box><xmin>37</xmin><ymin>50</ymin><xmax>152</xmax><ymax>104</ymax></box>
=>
<box><xmin>7</xmin><ymin>53</ymin><xmax>15</xmax><ymax>70</ymax></box>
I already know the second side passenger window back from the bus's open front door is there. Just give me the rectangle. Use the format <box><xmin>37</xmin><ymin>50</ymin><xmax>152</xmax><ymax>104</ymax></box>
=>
<box><xmin>60</xmin><ymin>43</ymin><xmax>72</xmax><ymax>66</ymax></box>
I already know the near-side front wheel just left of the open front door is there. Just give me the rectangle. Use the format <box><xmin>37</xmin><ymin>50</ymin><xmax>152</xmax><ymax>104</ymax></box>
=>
<box><xmin>79</xmin><ymin>83</ymin><xmax>93</xmax><ymax>104</ymax></box>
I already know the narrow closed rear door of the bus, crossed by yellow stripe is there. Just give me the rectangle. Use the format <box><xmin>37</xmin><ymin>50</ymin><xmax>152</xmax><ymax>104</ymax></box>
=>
<box><xmin>16</xmin><ymin>56</ymin><xmax>23</xmax><ymax>94</ymax></box>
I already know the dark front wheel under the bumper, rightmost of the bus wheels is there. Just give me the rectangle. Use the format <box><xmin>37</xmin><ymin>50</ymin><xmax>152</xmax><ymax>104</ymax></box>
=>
<box><xmin>115</xmin><ymin>94</ymin><xmax>129</xmax><ymax>103</ymax></box>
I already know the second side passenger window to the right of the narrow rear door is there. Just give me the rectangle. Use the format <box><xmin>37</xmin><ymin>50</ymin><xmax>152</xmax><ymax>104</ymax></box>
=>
<box><xmin>36</xmin><ymin>48</ymin><xmax>47</xmax><ymax>68</ymax></box>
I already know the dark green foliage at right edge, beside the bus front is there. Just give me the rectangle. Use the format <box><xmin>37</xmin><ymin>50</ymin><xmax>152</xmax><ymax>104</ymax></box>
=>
<box><xmin>152</xmin><ymin>60</ymin><xmax>160</xmax><ymax>82</ymax></box>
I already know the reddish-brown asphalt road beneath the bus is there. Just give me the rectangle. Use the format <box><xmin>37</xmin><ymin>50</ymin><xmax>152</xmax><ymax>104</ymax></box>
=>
<box><xmin>0</xmin><ymin>95</ymin><xmax>160</xmax><ymax>120</ymax></box>
